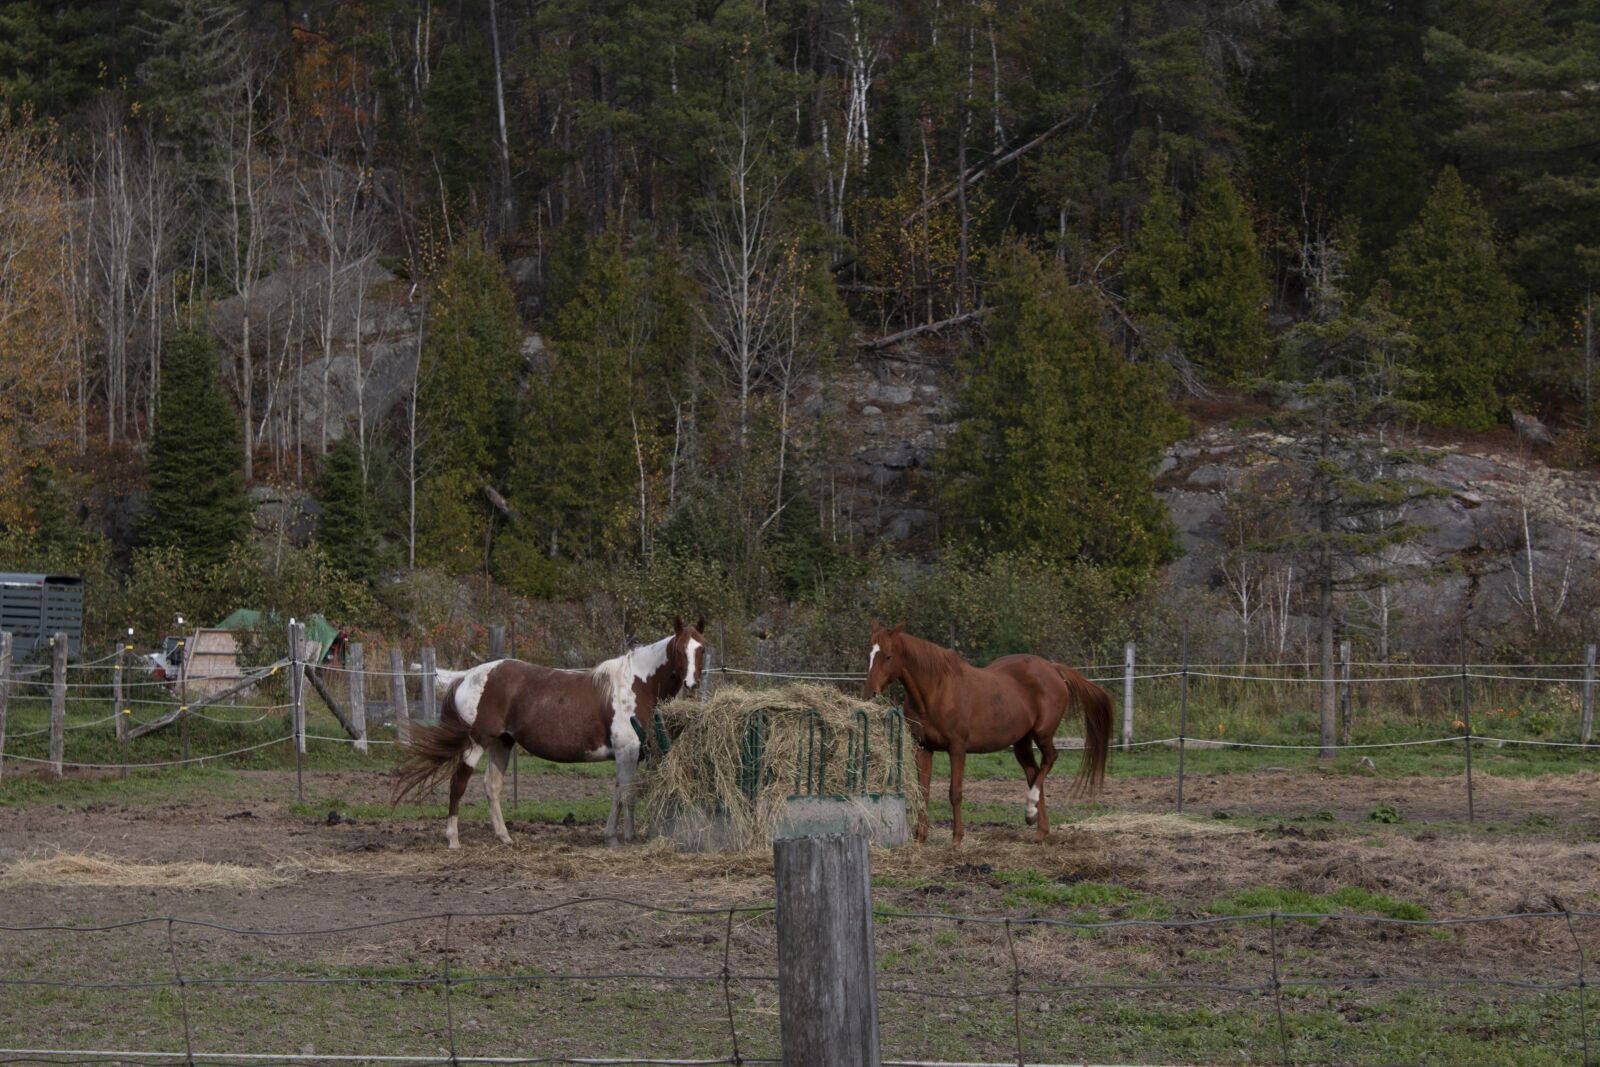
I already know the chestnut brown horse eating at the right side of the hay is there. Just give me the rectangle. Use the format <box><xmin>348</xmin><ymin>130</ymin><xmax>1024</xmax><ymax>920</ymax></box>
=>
<box><xmin>862</xmin><ymin>622</ymin><xmax>1110</xmax><ymax>845</ymax></box>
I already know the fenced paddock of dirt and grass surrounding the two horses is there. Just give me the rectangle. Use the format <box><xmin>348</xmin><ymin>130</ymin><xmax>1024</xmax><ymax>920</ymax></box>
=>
<box><xmin>0</xmin><ymin>630</ymin><xmax>1600</xmax><ymax>1064</ymax></box>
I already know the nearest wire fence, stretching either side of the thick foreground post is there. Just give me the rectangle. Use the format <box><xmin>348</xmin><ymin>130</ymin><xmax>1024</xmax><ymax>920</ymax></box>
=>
<box><xmin>0</xmin><ymin>896</ymin><xmax>1600</xmax><ymax>1067</ymax></box>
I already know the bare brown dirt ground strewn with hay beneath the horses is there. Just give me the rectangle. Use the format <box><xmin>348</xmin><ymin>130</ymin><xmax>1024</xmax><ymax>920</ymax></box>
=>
<box><xmin>0</xmin><ymin>771</ymin><xmax>1600</xmax><ymax>1062</ymax></box>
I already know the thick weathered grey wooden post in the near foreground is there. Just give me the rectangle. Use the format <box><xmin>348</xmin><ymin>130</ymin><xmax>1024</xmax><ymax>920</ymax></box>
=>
<box><xmin>773</xmin><ymin>833</ymin><xmax>882</xmax><ymax>1067</ymax></box>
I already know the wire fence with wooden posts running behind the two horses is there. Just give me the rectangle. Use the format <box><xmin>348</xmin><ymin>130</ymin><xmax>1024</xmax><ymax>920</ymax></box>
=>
<box><xmin>0</xmin><ymin>633</ymin><xmax>1597</xmax><ymax>821</ymax></box>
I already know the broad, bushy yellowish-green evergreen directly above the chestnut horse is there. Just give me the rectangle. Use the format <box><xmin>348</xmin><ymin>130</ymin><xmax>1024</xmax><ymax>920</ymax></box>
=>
<box><xmin>941</xmin><ymin>246</ymin><xmax>1179</xmax><ymax>581</ymax></box>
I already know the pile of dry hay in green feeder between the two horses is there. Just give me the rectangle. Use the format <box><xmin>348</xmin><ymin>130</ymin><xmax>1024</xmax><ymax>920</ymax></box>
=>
<box><xmin>635</xmin><ymin>683</ymin><xmax>922</xmax><ymax>846</ymax></box>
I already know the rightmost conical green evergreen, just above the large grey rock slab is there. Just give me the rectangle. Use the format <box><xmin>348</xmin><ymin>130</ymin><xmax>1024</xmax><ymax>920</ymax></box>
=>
<box><xmin>1387</xmin><ymin>166</ymin><xmax>1518</xmax><ymax>429</ymax></box>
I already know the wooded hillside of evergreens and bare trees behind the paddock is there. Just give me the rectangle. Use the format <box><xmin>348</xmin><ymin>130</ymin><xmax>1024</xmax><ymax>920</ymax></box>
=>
<box><xmin>0</xmin><ymin>0</ymin><xmax>1600</xmax><ymax>667</ymax></box>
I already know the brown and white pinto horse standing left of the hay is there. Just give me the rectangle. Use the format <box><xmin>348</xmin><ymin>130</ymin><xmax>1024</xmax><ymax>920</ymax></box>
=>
<box><xmin>395</xmin><ymin>619</ymin><xmax>706</xmax><ymax>848</ymax></box>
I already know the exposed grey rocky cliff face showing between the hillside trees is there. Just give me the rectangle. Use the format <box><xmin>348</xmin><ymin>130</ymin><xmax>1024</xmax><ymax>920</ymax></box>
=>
<box><xmin>228</xmin><ymin>266</ymin><xmax>1600</xmax><ymax>648</ymax></box>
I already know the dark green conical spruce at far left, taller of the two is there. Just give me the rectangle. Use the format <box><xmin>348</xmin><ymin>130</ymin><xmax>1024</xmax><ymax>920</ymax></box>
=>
<box><xmin>141</xmin><ymin>326</ymin><xmax>251</xmax><ymax>565</ymax></box>
